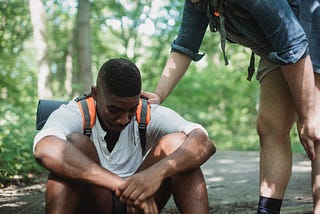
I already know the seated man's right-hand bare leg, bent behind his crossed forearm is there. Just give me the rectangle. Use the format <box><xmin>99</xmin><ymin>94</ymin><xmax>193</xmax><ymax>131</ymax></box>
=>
<box><xmin>139</xmin><ymin>133</ymin><xmax>209</xmax><ymax>214</ymax></box>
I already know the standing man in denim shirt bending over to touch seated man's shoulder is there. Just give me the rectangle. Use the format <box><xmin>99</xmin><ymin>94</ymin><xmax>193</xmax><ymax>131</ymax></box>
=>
<box><xmin>143</xmin><ymin>0</ymin><xmax>320</xmax><ymax>213</ymax></box>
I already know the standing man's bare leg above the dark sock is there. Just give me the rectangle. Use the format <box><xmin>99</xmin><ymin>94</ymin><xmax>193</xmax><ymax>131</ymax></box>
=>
<box><xmin>257</xmin><ymin>69</ymin><xmax>296</xmax><ymax>199</ymax></box>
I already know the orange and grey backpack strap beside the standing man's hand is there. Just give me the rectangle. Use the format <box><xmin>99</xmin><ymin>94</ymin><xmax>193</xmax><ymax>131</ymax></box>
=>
<box><xmin>136</xmin><ymin>98</ymin><xmax>151</xmax><ymax>156</ymax></box>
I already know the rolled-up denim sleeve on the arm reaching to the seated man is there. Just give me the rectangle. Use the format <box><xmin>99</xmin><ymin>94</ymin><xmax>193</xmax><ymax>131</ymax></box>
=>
<box><xmin>171</xmin><ymin>0</ymin><xmax>209</xmax><ymax>61</ymax></box>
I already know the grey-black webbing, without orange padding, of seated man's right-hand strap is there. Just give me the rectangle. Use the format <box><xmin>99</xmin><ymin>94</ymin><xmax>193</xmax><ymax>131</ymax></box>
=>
<box><xmin>139</xmin><ymin>98</ymin><xmax>148</xmax><ymax>156</ymax></box>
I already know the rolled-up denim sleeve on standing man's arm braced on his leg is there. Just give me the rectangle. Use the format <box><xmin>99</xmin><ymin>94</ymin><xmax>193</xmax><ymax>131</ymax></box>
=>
<box><xmin>235</xmin><ymin>0</ymin><xmax>308</xmax><ymax>65</ymax></box>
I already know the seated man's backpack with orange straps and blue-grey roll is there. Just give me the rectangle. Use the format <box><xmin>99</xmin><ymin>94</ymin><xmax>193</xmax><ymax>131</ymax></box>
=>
<box><xmin>36</xmin><ymin>93</ymin><xmax>151</xmax><ymax>155</ymax></box>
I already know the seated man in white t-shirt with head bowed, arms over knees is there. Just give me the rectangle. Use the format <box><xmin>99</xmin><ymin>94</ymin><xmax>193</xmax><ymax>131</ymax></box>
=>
<box><xmin>34</xmin><ymin>59</ymin><xmax>215</xmax><ymax>213</ymax></box>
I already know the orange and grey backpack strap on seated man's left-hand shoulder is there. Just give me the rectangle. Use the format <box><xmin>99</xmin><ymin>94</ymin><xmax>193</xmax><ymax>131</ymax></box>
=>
<box><xmin>76</xmin><ymin>95</ymin><xmax>96</xmax><ymax>137</ymax></box>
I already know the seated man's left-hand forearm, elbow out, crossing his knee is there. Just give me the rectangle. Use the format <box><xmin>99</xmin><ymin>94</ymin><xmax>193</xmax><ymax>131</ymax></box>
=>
<box><xmin>35</xmin><ymin>136</ymin><xmax>122</xmax><ymax>190</ymax></box>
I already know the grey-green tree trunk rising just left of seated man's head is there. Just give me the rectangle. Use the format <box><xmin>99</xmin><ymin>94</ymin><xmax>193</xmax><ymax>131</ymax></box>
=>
<box><xmin>75</xmin><ymin>0</ymin><xmax>93</xmax><ymax>93</ymax></box>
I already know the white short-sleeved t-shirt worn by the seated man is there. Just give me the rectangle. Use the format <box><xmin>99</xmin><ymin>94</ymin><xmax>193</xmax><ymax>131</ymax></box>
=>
<box><xmin>33</xmin><ymin>101</ymin><xmax>207</xmax><ymax>178</ymax></box>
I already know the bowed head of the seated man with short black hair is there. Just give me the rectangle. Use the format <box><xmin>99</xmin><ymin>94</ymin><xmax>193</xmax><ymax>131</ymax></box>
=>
<box><xmin>92</xmin><ymin>59</ymin><xmax>141</xmax><ymax>132</ymax></box>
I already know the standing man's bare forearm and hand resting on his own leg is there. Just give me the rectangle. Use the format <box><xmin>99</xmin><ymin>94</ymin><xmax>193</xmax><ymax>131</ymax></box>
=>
<box><xmin>281</xmin><ymin>56</ymin><xmax>320</xmax><ymax>160</ymax></box>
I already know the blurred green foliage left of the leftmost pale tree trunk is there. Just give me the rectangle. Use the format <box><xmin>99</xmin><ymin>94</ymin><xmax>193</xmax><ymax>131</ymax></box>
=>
<box><xmin>0</xmin><ymin>0</ymin><xmax>43</xmax><ymax>187</ymax></box>
